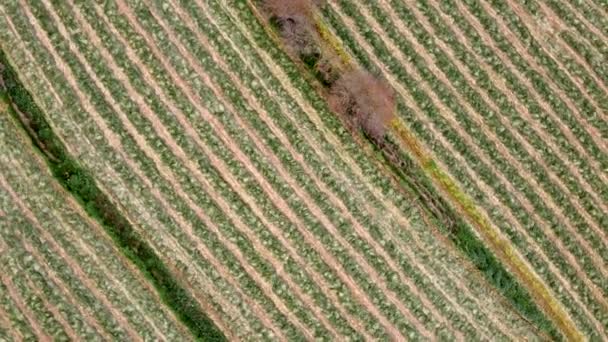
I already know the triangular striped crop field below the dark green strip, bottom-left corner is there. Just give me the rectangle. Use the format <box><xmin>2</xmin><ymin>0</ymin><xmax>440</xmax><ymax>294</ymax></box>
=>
<box><xmin>0</xmin><ymin>99</ymin><xmax>189</xmax><ymax>341</ymax></box>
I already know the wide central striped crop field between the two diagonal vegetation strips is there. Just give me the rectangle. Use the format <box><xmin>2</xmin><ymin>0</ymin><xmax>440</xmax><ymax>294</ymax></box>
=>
<box><xmin>0</xmin><ymin>0</ymin><xmax>537</xmax><ymax>340</ymax></box>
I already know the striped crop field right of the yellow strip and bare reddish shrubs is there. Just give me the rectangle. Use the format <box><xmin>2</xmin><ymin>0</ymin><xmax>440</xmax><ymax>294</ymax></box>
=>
<box><xmin>322</xmin><ymin>0</ymin><xmax>608</xmax><ymax>338</ymax></box>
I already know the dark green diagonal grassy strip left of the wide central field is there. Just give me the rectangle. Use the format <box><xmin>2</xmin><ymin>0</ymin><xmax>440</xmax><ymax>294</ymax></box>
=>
<box><xmin>0</xmin><ymin>50</ymin><xmax>226</xmax><ymax>341</ymax></box>
